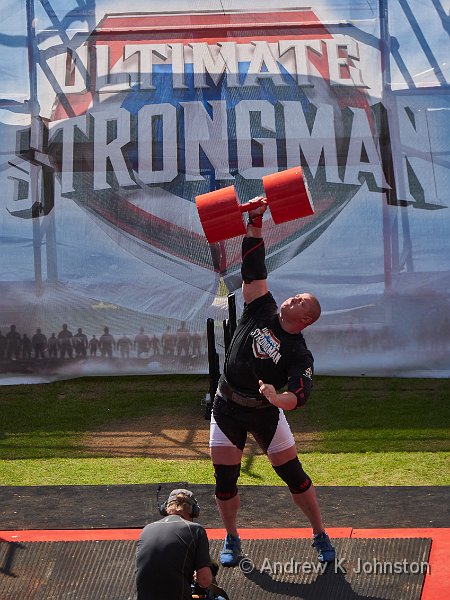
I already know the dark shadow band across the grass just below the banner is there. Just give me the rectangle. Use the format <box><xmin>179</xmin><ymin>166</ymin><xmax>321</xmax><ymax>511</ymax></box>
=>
<box><xmin>0</xmin><ymin>376</ymin><xmax>450</xmax><ymax>460</ymax></box>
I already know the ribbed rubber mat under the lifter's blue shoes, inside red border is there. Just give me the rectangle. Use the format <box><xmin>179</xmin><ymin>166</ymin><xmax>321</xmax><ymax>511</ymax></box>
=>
<box><xmin>0</xmin><ymin>538</ymin><xmax>431</xmax><ymax>600</ymax></box>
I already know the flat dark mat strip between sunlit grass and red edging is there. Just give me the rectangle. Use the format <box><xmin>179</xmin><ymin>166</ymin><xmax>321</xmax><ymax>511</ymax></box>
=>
<box><xmin>0</xmin><ymin>482</ymin><xmax>450</xmax><ymax>530</ymax></box>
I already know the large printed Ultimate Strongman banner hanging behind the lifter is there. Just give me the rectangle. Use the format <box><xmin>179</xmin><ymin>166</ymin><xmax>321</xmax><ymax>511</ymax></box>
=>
<box><xmin>0</xmin><ymin>0</ymin><xmax>450</xmax><ymax>384</ymax></box>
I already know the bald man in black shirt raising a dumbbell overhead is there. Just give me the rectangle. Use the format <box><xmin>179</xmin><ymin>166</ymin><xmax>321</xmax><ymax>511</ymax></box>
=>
<box><xmin>210</xmin><ymin>204</ymin><xmax>335</xmax><ymax>567</ymax></box>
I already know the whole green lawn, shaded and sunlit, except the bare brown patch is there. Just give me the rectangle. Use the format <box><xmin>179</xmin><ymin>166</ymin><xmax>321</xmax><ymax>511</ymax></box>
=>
<box><xmin>0</xmin><ymin>375</ymin><xmax>450</xmax><ymax>485</ymax></box>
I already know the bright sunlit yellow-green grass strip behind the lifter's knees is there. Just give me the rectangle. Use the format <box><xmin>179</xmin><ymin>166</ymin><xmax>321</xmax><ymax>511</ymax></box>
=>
<box><xmin>0</xmin><ymin>452</ymin><xmax>450</xmax><ymax>486</ymax></box>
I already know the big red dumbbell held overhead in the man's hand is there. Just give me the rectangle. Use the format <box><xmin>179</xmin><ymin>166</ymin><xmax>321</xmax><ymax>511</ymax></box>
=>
<box><xmin>195</xmin><ymin>167</ymin><xmax>314</xmax><ymax>244</ymax></box>
